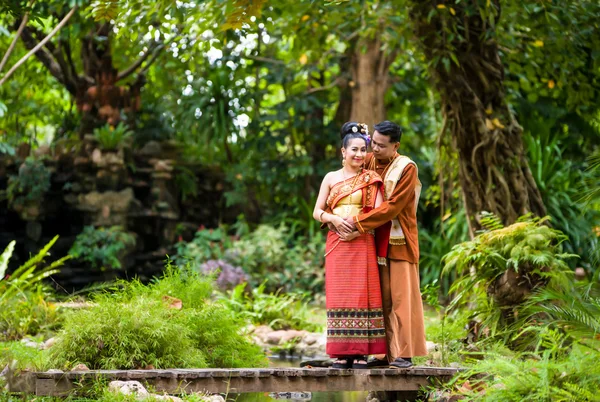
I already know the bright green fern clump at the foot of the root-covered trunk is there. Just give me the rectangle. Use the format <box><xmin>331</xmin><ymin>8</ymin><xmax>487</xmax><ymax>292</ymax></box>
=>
<box><xmin>443</xmin><ymin>215</ymin><xmax>576</xmax><ymax>335</ymax></box>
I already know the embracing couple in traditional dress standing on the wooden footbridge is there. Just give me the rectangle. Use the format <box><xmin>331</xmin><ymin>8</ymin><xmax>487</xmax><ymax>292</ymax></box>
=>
<box><xmin>313</xmin><ymin>121</ymin><xmax>427</xmax><ymax>369</ymax></box>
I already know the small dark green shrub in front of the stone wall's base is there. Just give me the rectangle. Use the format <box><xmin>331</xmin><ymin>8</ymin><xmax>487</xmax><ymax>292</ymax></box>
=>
<box><xmin>69</xmin><ymin>226</ymin><xmax>136</xmax><ymax>269</ymax></box>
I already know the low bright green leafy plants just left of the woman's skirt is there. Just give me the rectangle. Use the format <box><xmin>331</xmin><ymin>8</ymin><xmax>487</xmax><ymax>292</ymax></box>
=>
<box><xmin>220</xmin><ymin>283</ymin><xmax>321</xmax><ymax>332</ymax></box>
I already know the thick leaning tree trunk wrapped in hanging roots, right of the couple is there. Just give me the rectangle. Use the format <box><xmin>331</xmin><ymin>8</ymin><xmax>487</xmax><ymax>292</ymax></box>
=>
<box><xmin>411</xmin><ymin>0</ymin><xmax>546</xmax><ymax>233</ymax></box>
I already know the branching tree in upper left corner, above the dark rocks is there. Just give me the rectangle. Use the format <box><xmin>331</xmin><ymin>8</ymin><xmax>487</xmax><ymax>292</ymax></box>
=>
<box><xmin>1</xmin><ymin>1</ymin><xmax>208</xmax><ymax>137</ymax></box>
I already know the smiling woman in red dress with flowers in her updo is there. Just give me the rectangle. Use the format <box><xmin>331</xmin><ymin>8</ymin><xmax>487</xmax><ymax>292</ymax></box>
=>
<box><xmin>313</xmin><ymin>122</ymin><xmax>386</xmax><ymax>368</ymax></box>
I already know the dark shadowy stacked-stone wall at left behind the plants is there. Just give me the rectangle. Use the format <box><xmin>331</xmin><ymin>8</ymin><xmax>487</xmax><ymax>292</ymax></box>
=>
<box><xmin>0</xmin><ymin>140</ymin><xmax>239</xmax><ymax>292</ymax></box>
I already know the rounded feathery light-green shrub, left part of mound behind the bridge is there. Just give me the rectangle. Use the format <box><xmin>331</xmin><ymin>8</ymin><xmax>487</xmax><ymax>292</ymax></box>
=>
<box><xmin>50</xmin><ymin>294</ymin><xmax>206</xmax><ymax>369</ymax></box>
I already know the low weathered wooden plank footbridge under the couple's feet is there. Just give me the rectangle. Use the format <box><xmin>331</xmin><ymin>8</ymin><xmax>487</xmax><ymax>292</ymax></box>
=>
<box><xmin>11</xmin><ymin>367</ymin><xmax>457</xmax><ymax>396</ymax></box>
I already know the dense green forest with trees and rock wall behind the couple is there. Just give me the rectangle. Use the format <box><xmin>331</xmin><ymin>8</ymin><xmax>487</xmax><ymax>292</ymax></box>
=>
<box><xmin>0</xmin><ymin>0</ymin><xmax>600</xmax><ymax>398</ymax></box>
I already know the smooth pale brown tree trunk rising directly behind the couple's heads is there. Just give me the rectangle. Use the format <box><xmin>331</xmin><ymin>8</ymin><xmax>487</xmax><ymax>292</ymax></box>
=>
<box><xmin>350</xmin><ymin>35</ymin><xmax>396</xmax><ymax>127</ymax></box>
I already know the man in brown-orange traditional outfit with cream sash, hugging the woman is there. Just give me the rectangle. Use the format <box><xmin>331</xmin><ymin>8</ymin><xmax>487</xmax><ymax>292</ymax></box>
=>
<box><xmin>348</xmin><ymin>121</ymin><xmax>427</xmax><ymax>368</ymax></box>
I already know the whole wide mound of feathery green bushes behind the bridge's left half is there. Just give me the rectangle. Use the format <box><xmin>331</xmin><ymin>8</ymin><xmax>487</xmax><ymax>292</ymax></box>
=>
<box><xmin>51</xmin><ymin>265</ymin><xmax>266</xmax><ymax>369</ymax></box>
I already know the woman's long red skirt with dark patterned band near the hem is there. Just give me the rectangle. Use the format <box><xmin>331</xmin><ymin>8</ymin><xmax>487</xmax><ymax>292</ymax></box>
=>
<box><xmin>325</xmin><ymin>231</ymin><xmax>386</xmax><ymax>358</ymax></box>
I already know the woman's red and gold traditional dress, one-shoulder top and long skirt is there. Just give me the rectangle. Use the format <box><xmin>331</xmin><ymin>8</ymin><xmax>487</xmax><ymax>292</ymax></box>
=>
<box><xmin>325</xmin><ymin>170</ymin><xmax>386</xmax><ymax>358</ymax></box>
